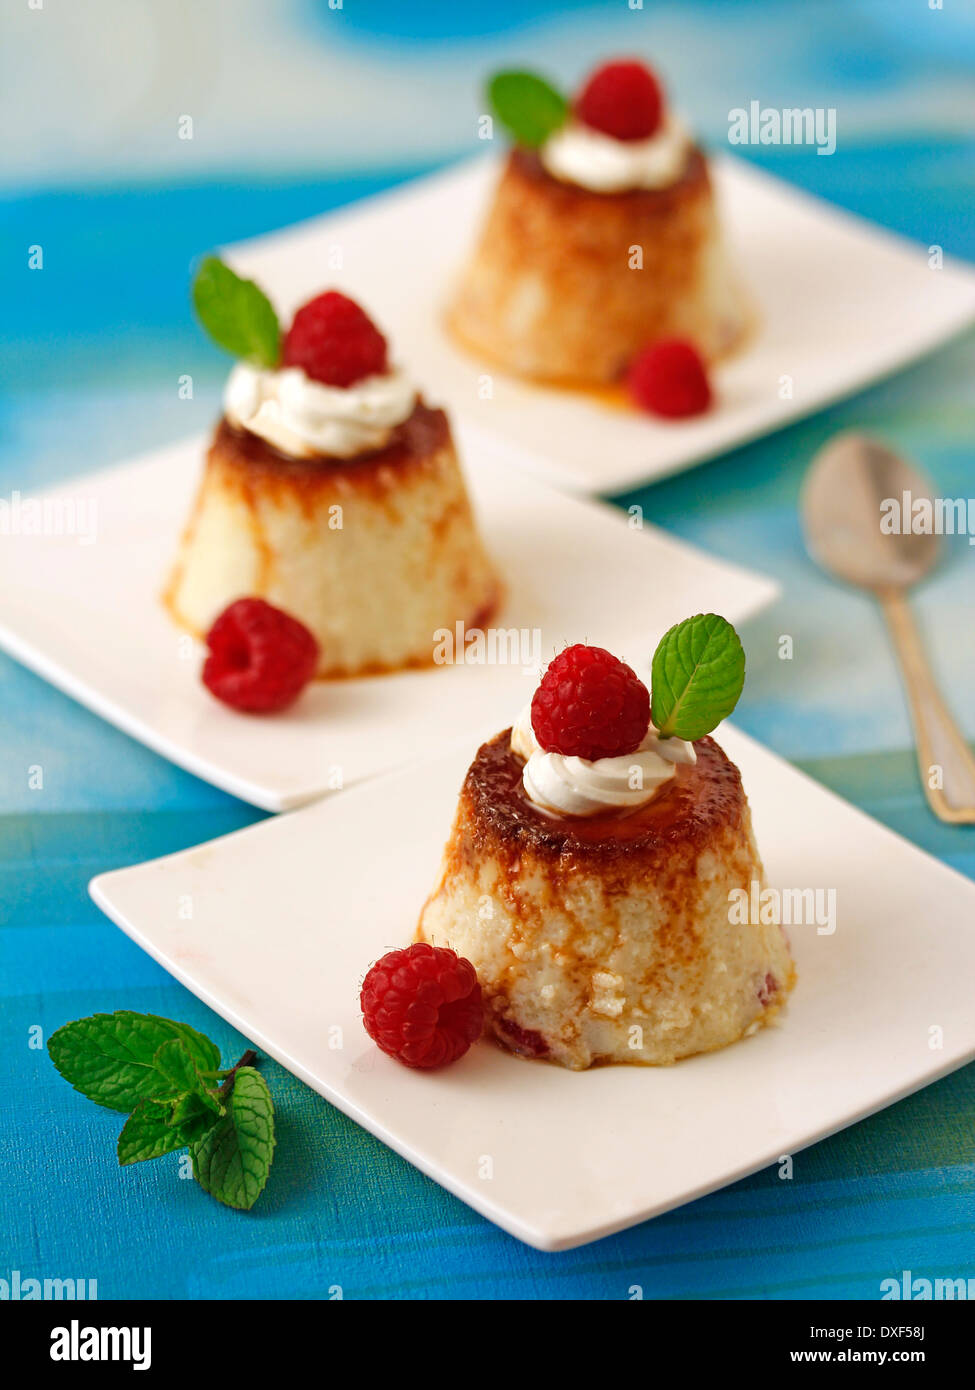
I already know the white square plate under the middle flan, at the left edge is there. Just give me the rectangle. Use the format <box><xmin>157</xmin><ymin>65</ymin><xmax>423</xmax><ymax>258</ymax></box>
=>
<box><xmin>0</xmin><ymin>427</ymin><xmax>777</xmax><ymax>810</ymax></box>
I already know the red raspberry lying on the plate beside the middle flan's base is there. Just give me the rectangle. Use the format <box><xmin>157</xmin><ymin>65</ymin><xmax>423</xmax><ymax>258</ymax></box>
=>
<box><xmin>203</xmin><ymin>599</ymin><xmax>319</xmax><ymax>714</ymax></box>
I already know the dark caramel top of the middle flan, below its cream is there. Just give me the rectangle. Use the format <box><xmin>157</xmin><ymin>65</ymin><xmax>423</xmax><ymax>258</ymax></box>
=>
<box><xmin>211</xmin><ymin>396</ymin><xmax>451</xmax><ymax>488</ymax></box>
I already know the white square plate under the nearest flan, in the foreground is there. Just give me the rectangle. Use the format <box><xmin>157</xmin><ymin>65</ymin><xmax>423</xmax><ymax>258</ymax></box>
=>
<box><xmin>90</xmin><ymin>726</ymin><xmax>975</xmax><ymax>1250</ymax></box>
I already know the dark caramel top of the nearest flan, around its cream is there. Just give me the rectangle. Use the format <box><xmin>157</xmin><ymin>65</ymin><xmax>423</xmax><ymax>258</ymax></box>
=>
<box><xmin>460</xmin><ymin>728</ymin><xmax>747</xmax><ymax>863</ymax></box>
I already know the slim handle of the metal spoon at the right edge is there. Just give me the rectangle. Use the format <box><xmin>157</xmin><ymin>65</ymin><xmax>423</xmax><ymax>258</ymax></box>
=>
<box><xmin>879</xmin><ymin>589</ymin><xmax>975</xmax><ymax>824</ymax></box>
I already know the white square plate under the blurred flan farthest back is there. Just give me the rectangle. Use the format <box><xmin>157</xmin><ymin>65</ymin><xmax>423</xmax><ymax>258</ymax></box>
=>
<box><xmin>227</xmin><ymin>156</ymin><xmax>975</xmax><ymax>492</ymax></box>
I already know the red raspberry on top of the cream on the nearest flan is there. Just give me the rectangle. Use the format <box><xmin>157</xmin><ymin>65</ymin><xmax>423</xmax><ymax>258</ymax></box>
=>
<box><xmin>531</xmin><ymin>644</ymin><xmax>650</xmax><ymax>759</ymax></box>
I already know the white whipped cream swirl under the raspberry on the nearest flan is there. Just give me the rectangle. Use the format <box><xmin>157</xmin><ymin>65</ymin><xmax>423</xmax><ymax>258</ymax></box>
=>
<box><xmin>510</xmin><ymin>705</ymin><xmax>697</xmax><ymax>816</ymax></box>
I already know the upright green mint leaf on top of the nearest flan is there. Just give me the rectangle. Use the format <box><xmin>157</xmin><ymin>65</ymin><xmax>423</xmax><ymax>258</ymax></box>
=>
<box><xmin>650</xmin><ymin>613</ymin><xmax>744</xmax><ymax>742</ymax></box>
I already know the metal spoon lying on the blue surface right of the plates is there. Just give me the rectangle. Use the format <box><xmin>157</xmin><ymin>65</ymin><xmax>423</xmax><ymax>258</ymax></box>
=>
<box><xmin>801</xmin><ymin>434</ymin><xmax>975</xmax><ymax>824</ymax></box>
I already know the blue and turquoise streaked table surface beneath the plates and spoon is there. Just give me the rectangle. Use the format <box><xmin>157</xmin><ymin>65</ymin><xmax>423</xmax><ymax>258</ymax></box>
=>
<box><xmin>0</xmin><ymin>0</ymin><xmax>975</xmax><ymax>1298</ymax></box>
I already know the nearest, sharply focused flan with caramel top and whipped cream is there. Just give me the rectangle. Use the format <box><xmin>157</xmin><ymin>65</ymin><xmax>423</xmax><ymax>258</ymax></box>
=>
<box><xmin>417</xmin><ymin>625</ymin><xmax>794</xmax><ymax>1070</ymax></box>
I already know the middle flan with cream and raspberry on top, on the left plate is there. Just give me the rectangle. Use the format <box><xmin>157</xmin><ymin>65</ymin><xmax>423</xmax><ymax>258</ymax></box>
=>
<box><xmin>166</xmin><ymin>267</ymin><xmax>498</xmax><ymax>678</ymax></box>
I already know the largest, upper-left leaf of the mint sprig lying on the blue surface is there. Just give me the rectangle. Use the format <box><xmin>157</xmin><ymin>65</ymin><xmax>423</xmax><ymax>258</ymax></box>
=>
<box><xmin>47</xmin><ymin>1009</ymin><xmax>220</xmax><ymax>1112</ymax></box>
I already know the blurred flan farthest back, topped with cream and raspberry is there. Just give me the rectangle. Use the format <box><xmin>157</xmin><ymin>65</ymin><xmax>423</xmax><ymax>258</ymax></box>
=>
<box><xmin>448</xmin><ymin>61</ymin><xmax>752</xmax><ymax>389</ymax></box>
